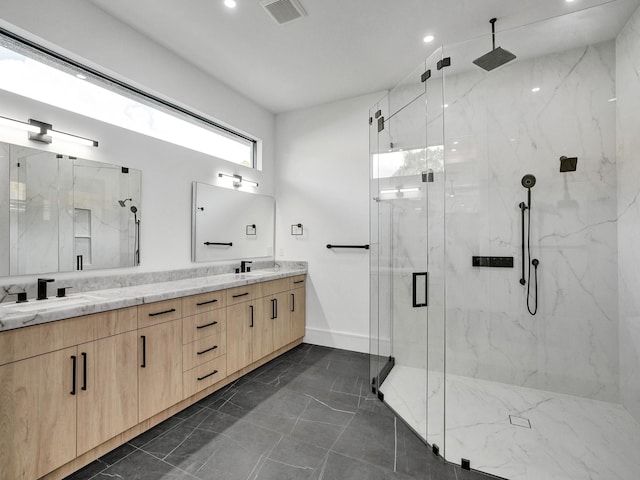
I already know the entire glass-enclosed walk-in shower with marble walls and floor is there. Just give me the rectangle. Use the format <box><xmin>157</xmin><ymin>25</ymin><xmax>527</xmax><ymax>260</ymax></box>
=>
<box><xmin>369</xmin><ymin>0</ymin><xmax>640</xmax><ymax>480</ymax></box>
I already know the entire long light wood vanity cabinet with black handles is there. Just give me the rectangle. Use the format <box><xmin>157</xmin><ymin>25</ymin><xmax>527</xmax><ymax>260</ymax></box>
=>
<box><xmin>0</xmin><ymin>275</ymin><xmax>306</xmax><ymax>480</ymax></box>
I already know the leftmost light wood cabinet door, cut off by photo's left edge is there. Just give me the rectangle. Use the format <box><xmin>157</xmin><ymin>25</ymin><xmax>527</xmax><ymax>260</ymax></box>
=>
<box><xmin>0</xmin><ymin>347</ymin><xmax>78</xmax><ymax>480</ymax></box>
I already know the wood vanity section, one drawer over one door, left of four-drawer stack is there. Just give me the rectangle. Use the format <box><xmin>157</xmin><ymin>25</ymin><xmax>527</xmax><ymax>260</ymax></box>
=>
<box><xmin>138</xmin><ymin>299</ymin><xmax>183</xmax><ymax>422</ymax></box>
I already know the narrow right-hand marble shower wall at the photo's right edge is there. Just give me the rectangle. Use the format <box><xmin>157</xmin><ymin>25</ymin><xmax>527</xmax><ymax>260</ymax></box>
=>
<box><xmin>616</xmin><ymin>9</ymin><xmax>640</xmax><ymax>421</ymax></box>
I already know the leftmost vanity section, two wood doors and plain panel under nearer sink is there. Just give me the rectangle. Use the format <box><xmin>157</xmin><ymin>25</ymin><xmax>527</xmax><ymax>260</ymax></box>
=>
<box><xmin>0</xmin><ymin>308</ymin><xmax>138</xmax><ymax>480</ymax></box>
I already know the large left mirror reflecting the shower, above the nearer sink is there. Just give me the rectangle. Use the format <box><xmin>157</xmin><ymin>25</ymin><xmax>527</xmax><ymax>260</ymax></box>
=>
<box><xmin>0</xmin><ymin>142</ymin><xmax>141</xmax><ymax>276</ymax></box>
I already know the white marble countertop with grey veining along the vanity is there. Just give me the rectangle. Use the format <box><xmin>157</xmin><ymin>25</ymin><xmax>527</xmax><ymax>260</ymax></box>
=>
<box><xmin>0</xmin><ymin>265</ymin><xmax>307</xmax><ymax>331</ymax></box>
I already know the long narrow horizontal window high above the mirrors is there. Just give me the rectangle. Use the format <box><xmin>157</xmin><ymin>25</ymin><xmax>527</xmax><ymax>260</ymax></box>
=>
<box><xmin>0</xmin><ymin>32</ymin><xmax>256</xmax><ymax>168</ymax></box>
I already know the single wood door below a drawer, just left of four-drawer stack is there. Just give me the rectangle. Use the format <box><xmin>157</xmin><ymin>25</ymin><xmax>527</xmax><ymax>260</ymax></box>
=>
<box><xmin>138</xmin><ymin>320</ymin><xmax>183</xmax><ymax>422</ymax></box>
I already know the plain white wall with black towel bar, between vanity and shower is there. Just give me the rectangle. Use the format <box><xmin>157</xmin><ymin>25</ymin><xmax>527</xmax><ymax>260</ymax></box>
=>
<box><xmin>275</xmin><ymin>94</ymin><xmax>382</xmax><ymax>352</ymax></box>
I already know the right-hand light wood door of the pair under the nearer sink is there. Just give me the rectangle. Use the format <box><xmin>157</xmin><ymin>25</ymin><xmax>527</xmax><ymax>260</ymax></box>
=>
<box><xmin>78</xmin><ymin>331</ymin><xmax>138</xmax><ymax>455</ymax></box>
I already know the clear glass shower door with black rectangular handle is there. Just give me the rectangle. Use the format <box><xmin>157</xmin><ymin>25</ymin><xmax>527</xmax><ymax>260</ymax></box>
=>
<box><xmin>370</xmin><ymin>48</ymin><xmax>444</xmax><ymax>454</ymax></box>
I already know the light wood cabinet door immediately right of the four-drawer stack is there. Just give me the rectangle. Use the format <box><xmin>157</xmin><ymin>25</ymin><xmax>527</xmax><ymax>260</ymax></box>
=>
<box><xmin>227</xmin><ymin>300</ymin><xmax>264</xmax><ymax>374</ymax></box>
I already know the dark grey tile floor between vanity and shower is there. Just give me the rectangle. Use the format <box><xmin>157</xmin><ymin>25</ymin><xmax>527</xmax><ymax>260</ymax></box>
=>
<box><xmin>66</xmin><ymin>344</ymin><xmax>489</xmax><ymax>480</ymax></box>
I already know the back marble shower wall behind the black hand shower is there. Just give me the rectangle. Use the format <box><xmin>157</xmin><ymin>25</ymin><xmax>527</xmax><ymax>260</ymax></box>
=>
<box><xmin>444</xmin><ymin>41</ymin><xmax>620</xmax><ymax>401</ymax></box>
